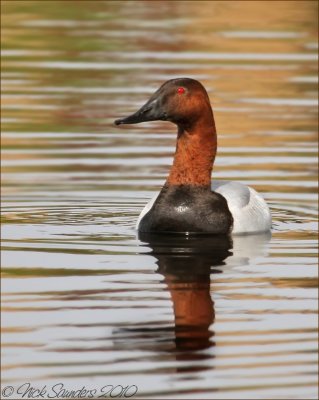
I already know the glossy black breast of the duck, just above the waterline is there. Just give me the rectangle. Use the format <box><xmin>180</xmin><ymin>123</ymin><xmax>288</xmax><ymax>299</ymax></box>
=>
<box><xmin>139</xmin><ymin>185</ymin><xmax>233</xmax><ymax>234</ymax></box>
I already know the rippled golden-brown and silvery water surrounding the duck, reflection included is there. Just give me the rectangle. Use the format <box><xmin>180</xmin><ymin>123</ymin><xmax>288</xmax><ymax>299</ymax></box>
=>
<box><xmin>1</xmin><ymin>1</ymin><xmax>318</xmax><ymax>399</ymax></box>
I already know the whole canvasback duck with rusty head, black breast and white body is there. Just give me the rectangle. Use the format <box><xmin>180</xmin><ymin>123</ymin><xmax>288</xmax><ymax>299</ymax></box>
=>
<box><xmin>115</xmin><ymin>78</ymin><xmax>271</xmax><ymax>234</ymax></box>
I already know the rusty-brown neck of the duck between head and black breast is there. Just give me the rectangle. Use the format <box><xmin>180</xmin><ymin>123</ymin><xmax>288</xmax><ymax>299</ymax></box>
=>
<box><xmin>166</xmin><ymin>112</ymin><xmax>217</xmax><ymax>188</ymax></box>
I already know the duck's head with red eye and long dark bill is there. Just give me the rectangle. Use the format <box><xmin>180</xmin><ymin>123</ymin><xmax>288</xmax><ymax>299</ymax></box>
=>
<box><xmin>114</xmin><ymin>78</ymin><xmax>212</xmax><ymax>126</ymax></box>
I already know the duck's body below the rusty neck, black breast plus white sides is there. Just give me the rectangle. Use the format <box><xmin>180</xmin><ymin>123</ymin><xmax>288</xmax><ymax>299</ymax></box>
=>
<box><xmin>136</xmin><ymin>181</ymin><xmax>271</xmax><ymax>235</ymax></box>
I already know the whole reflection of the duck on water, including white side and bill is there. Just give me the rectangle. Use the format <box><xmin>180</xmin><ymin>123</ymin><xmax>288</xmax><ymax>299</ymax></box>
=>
<box><xmin>113</xmin><ymin>233</ymin><xmax>271</xmax><ymax>356</ymax></box>
